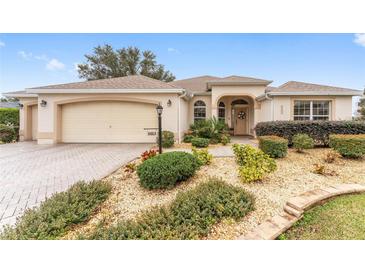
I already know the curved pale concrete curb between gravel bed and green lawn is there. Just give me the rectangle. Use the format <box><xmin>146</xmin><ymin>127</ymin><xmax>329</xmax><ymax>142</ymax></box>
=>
<box><xmin>237</xmin><ymin>184</ymin><xmax>365</xmax><ymax>240</ymax></box>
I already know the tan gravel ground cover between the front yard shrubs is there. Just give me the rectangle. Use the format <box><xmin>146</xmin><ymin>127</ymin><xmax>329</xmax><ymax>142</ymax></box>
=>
<box><xmin>59</xmin><ymin>148</ymin><xmax>365</xmax><ymax>239</ymax></box>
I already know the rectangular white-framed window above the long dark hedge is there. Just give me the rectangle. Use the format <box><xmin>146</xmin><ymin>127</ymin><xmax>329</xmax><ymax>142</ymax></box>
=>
<box><xmin>294</xmin><ymin>100</ymin><xmax>331</xmax><ymax>121</ymax></box>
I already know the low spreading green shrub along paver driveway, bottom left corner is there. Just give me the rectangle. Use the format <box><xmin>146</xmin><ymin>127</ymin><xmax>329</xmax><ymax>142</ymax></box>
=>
<box><xmin>0</xmin><ymin>181</ymin><xmax>112</xmax><ymax>240</ymax></box>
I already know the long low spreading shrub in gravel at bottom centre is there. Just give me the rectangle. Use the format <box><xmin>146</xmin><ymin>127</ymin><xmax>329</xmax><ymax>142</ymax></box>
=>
<box><xmin>83</xmin><ymin>178</ymin><xmax>254</xmax><ymax>240</ymax></box>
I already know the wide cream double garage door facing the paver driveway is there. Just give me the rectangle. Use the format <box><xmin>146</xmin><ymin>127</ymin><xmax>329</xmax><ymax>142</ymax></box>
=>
<box><xmin>62</xmin><ymin>101</ymin><xmax>158</xmax><ymax>143</ymax></box>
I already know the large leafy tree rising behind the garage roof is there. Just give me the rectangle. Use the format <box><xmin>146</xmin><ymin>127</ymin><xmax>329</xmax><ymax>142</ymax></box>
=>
<box><xmin>78</xmin><ymin>45</ymin><xmax>175</xmax><ymax>82</ymax></box>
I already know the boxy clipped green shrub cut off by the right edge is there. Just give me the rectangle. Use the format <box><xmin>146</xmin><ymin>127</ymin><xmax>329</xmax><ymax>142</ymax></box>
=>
<box><xmin>330</xmin><ymin>134</ymin><xmax>365</xmax><ymax>158</ymax></box>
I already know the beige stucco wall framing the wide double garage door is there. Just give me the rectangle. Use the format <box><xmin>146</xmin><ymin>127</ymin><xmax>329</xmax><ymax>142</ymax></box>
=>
<box><xmin>34</xmin><ymin>93</ymin><xmax>179</xmax><ymax>144</ymax></box>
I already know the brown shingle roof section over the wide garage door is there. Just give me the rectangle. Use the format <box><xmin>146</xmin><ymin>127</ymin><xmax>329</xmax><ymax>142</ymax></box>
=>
<box><xmin>29</xmin><ymin>75</ymin><xmax>179</xmax><ymax>89</ymax></box>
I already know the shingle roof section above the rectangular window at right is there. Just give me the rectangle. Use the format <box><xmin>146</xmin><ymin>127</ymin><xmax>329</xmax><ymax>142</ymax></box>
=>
<box><xmin>270</xmin><ymin>81</ymin><xmax>360</xmax><ymax>92</ymax></box>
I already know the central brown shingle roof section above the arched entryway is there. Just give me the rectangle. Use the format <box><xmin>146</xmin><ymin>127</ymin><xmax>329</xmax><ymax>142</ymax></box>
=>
<box><xmin>172</xmin><ymin>75</ymin><xmax>271</xmax><ymax>91</ymax></box>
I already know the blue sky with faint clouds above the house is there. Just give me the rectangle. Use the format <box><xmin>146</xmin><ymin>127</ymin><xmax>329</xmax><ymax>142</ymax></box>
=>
<box><xmin>0</xmin><ymin>34</ymin><xmax>365</xmax><ymax>93</ymax></box>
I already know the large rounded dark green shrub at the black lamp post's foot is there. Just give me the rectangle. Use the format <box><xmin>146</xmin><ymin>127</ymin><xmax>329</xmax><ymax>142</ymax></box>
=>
<box><xmin>137</xmin><ymin>151</ymin><xmax>200</xmax><ymax>189</ymax></box>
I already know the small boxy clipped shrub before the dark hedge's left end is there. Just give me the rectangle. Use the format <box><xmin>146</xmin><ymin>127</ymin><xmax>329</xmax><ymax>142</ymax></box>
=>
<box><xmin>259</xmin><ymin>136</ymin><xmax>288</xmax><ymax>158</ymax></box>
